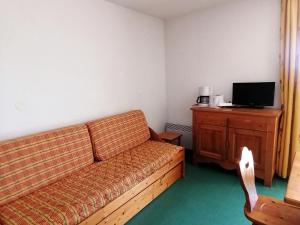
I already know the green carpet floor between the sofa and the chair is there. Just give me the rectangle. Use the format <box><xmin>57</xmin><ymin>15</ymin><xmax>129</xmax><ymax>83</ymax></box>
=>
<box><xmin>127</xmin><ymin>151</ymin><xmax>287</xmax><ymax>225</ymax></box>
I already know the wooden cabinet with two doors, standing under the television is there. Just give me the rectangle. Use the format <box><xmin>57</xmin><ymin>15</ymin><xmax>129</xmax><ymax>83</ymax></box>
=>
<box><xmin>192</xmin><ymin>107</ymin><xmax>281</xmax><ymax>186</ymax></box>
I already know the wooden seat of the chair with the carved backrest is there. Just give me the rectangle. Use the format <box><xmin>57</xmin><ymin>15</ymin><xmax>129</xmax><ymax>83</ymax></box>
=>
<box><xmin>245</xmin><ymin>195</ymin><xmax>300</xmax><ymax>225</ymax></box>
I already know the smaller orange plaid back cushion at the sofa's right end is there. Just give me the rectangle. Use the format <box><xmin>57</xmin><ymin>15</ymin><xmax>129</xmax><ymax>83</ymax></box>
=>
<box><xmin>87</xmin><ymin>110</ymin><xmax>150</xmax><ymax>160</ymax></box>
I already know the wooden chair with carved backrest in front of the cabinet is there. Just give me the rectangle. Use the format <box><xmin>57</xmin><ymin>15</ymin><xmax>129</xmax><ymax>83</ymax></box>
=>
<box><xmin>238</xmin><ymin>147</ymin><xmax>300</xmax><ymax>225</ymax></box>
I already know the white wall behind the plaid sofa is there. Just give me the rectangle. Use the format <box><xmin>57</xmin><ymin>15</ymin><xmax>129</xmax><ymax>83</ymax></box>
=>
<box><xmin>0</xmin><ymin>0</ymin><xmax>167</xmax><ymax>140</ymax></box>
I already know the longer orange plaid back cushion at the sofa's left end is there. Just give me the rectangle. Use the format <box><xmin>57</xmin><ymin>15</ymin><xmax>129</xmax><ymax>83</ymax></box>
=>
<box><xmin>0</xmin><ymin>125</ymin><xmax>93</xmax><ymax>205</ymax></box>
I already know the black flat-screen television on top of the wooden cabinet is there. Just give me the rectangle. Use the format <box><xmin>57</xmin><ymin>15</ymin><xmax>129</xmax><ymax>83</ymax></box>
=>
<box><xmin>232</xmin><ymin>82</ymin><xmax>275</xmax><ymax>107</ymax></box>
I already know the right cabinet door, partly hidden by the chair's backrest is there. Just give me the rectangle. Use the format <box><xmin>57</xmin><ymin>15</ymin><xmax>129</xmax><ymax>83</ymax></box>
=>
<box><xmin>229</xmin><ymin>128</ymin><xmax>267</xmax><ymax>170</ymax></box>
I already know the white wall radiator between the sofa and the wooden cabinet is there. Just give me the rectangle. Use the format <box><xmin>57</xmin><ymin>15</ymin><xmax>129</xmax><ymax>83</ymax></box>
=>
<box><xmin>166</xmin><ymin>123</ymin><xmax>193</xmax><ymax>149</ymax></box>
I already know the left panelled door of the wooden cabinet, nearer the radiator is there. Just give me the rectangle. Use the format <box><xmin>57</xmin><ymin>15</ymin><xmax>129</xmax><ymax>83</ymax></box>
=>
<box><xmin>196</xmin><ymin>123</ymin><xmax>226</xmax><ymax>160</ymax></box>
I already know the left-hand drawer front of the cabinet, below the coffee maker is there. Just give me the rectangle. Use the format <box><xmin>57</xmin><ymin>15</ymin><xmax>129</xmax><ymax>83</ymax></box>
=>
<box><xmin>194</xmin><ymin>112</ymin><xmax>226</xmax><ymax>127</ymax></box>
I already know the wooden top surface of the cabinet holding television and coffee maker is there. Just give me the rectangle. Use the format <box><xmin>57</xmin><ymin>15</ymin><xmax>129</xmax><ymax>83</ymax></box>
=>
<box><xmin>191</xmin><ymin>105</ymin><xmax>281</xmax><ymax>117</ymax></box>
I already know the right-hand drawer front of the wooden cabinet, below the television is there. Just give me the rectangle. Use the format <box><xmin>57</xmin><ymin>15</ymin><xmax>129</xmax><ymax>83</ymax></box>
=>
<box><xmin>228</xmin><ymin>117</ymin><xmax>268</xmax><ymax>131</ymax></box>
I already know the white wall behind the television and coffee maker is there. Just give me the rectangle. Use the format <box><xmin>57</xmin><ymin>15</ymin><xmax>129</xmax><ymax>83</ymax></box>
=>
<box><xmin>165</xmin><ymin>0</ymin><xmax>280</xmax><ymax>125</ymax></box>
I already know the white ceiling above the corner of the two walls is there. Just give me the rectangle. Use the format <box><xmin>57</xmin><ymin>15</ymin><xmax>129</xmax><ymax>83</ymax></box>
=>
<box><xmin>107</xmin><ymin>0</ymin><xmax>232</xmax><ymax>19</ymax></box>
